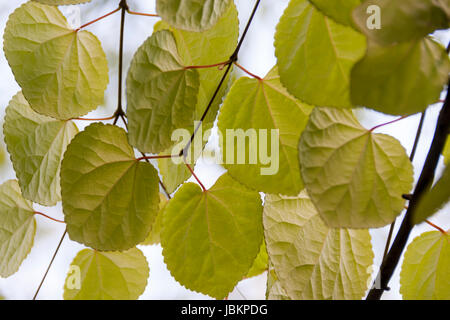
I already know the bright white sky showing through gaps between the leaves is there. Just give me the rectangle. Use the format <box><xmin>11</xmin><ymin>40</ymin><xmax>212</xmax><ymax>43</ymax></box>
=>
<box><xmin>0</xmin><ymin>0</ymin><xmax>450</xmax><ymax>299</ymax></box>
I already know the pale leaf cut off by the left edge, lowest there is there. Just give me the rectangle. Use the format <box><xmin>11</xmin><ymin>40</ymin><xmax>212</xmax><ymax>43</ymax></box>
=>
<box><xmin>0</xmin><ymin>180</ymin><xmax>36</xmax><ymax>278</ymax></box>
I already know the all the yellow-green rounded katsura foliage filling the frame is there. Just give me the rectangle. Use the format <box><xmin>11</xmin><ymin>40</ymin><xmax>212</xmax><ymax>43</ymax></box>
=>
<box><xmin>0</xmin><ymin>0</ymin><xmax>450</xmax><ymax>300</ymax></box>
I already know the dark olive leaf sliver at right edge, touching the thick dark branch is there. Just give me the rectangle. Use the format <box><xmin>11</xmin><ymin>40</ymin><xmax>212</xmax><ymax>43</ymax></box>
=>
<box><xmin>413</xmin><ymin>166</ymin><xmax>450</xmax><ymax>224</ymax></box>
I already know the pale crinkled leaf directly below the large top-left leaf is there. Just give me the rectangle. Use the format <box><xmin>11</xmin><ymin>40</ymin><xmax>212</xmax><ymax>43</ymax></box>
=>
<box><xmin>3</xmin><ymin>92</ymin><xmax>78</xmax><ymax>206</ymax></box>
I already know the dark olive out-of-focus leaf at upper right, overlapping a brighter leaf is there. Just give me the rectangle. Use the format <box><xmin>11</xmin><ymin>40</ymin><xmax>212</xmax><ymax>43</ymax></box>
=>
<box><xmin>351</xmin><ymin>39</ymin><xmax>450</xmax><ymax>115</ymax></box>
